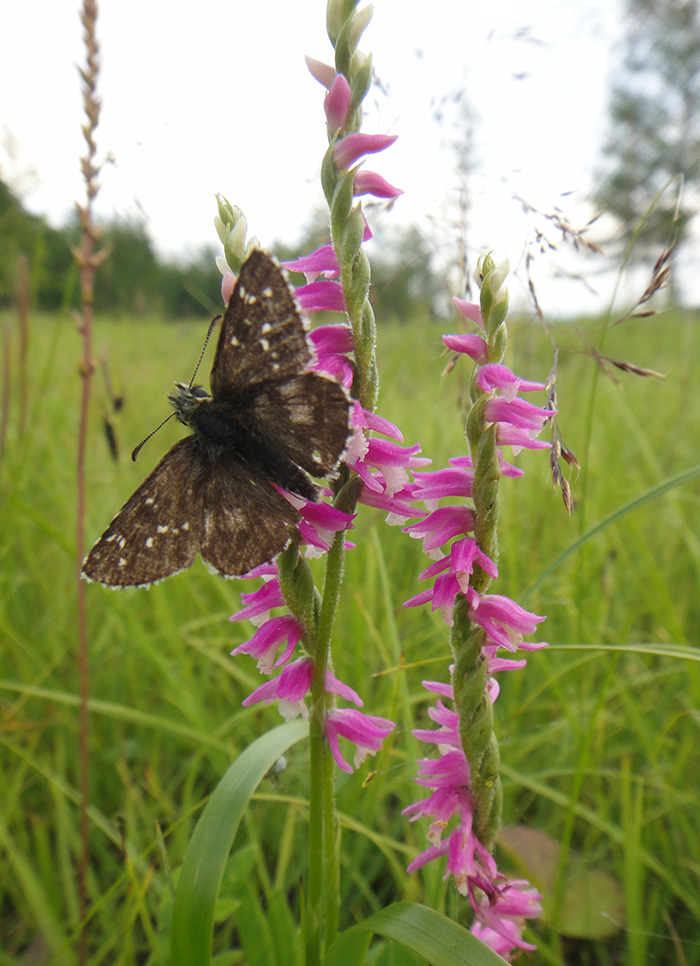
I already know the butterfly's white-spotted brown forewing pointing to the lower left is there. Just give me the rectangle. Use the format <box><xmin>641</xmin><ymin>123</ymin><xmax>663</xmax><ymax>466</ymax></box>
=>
<box><xmin>82</xmin><ymin>436</ymin><xmax>204</xmax><ymax>587</ymax></box>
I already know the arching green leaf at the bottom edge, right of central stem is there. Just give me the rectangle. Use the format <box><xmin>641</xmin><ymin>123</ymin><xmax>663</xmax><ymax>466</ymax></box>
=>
<box><xmin>324</xmin><ymin>902</ymin><xmax>503</xmax><ymax>966</ymax></box>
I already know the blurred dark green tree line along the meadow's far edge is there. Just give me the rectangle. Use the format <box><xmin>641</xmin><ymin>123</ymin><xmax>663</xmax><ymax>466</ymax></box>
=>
<box><xmin>0</xmin><ymin>180</ymin><xmax>444</xmax><ymax>328</ymax></box>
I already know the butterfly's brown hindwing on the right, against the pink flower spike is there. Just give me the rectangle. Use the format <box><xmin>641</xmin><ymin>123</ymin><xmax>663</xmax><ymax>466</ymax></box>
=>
<box><xmin>250</xmin><ymin>372</ymin><xmax>350</xmax><ymax>477</ymax></box>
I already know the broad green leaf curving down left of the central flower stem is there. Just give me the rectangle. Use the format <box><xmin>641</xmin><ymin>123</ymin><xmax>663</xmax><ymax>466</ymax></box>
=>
<box><xmin>170</xmin><ymin>721</ymin><xmax>309</xmax><ymax>966</ymax></box>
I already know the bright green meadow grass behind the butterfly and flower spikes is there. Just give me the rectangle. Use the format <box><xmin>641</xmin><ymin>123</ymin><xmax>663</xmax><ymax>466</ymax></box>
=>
<box><xmin>0</xmin><ymin>306</ymin><xmax>700</xmax><ymax>966</ymax></box>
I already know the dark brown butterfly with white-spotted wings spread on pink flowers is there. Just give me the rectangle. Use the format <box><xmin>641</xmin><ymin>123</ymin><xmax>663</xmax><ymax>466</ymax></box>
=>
<box><xmin>82</xmin><ymin>249</ymin><xmax>351</xmax><ymax>587</ymax></box>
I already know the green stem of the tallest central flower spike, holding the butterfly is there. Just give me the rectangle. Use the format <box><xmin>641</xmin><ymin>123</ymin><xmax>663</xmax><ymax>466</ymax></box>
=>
<box><xmin>304</xmin><ymin>0</ymin><xmax>378</xmax><ymax>966</ymax></box>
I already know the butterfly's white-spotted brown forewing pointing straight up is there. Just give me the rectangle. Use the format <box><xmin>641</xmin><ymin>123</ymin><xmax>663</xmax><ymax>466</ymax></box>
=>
<box><xmin>211</xmin><ymin>249</ymin><xmax>311</xmax><ymax>398</ymax></box>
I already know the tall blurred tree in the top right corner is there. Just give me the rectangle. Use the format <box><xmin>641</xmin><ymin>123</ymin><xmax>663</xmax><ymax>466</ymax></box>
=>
<box><xmin>595</xmin><ymin>0</ymin><xmax>700</xmax><ymax>295</ymax></box>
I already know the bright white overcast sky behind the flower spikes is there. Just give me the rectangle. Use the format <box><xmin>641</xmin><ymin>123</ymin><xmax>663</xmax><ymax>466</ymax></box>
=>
<box><xmin>0</xmin><ymin>0</ymin><xmax>652</xmax><ymax>311</ymax></box>
